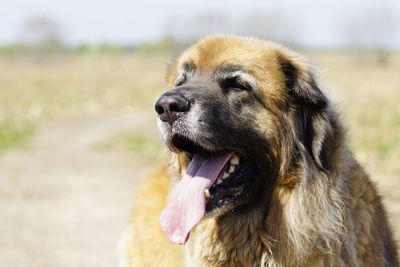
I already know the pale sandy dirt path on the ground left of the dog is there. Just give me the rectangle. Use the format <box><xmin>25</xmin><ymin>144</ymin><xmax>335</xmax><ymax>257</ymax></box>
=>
<box><xmin>0</xmin><ymin>115</ymin><xmax>156</xmax><ymax>267</ymax></box>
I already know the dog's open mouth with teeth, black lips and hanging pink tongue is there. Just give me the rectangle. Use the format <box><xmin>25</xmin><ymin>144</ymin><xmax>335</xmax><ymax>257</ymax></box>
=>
<box><xmin>160</xmin><ymin>134</ymin><xmax>252</xmax><ymax>244</ymax></box>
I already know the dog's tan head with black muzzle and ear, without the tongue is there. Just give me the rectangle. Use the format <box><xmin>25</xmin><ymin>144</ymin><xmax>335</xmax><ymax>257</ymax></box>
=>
<box><xmin>155</xmin><ymin>36</ymin><xmax>326</xmax><ymax>219</ymax></box>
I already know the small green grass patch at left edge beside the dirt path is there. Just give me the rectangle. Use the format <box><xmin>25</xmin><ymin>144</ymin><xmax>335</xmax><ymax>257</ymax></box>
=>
<box><xmin>0</xmin><ymin>119</ymin><xmax>36</xmax><ymax>153</ymax></box>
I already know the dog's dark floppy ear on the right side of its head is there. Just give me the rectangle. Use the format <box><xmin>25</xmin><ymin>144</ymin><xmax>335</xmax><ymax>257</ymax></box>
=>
<box><xmin>280</xmin><ymin>54</ymin><xmax>332</xmax><ymax>171</ymax></box>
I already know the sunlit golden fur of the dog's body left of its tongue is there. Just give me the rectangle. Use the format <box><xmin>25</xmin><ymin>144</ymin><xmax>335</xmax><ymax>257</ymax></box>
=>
<box><xmin>118</xmin><ymin>164</ymin><xmax>183</xmax><ymax>267</ymax></box>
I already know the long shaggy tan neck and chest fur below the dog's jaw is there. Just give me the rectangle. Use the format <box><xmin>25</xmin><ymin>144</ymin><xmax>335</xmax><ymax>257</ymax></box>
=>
<box><xmin>185</xmin><ymin>115</ymin><xmax>355</xmax><ymax>267</ymax></box>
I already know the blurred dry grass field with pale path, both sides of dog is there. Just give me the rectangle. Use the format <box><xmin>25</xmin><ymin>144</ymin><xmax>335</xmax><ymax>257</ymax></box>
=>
<box><xmin>0</xmin><ymin>52</ymin><xmax>400</xmax><ymax>267</ymax></box>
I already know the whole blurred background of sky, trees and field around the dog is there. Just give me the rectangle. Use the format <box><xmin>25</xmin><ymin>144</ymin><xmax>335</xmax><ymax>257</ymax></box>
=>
<box><xmin>0</xmin><ymin>0</ymin><xmax>400</xmax><ymax>267</ymax></box>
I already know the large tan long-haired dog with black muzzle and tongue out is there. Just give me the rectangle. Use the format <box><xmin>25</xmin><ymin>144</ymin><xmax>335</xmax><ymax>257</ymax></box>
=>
<box><xmin>120</xmin><ymin>35</ymin><xmax>399</xmax><ymax>267</ymax></box>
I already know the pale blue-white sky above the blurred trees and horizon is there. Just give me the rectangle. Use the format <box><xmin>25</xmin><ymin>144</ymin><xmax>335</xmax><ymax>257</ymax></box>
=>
<box><xmin>0</xmin><ymin>0</ymin><xmax>400</xmax><ymax>49</ymax></box>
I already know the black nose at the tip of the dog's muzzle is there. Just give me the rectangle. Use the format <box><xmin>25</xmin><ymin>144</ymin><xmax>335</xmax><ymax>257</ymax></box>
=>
<box><xmin>155</xmin><ymin>92</ymin><xmax>190</xmax><ymax>125</ymax></box>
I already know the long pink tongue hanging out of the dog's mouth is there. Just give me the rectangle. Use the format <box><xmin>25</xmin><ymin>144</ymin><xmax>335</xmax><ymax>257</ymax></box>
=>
<box><xmin>160</xmin><ymin>153</ymin><xmax>232</xmax><ymax>245</ymax></box>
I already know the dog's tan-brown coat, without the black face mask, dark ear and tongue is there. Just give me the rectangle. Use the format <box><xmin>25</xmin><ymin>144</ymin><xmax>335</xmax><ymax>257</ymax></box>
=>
<box><xmin>121</xmin><ymin>36</ymin><xmax>399</xmax><ymax>266</ymax></box>
